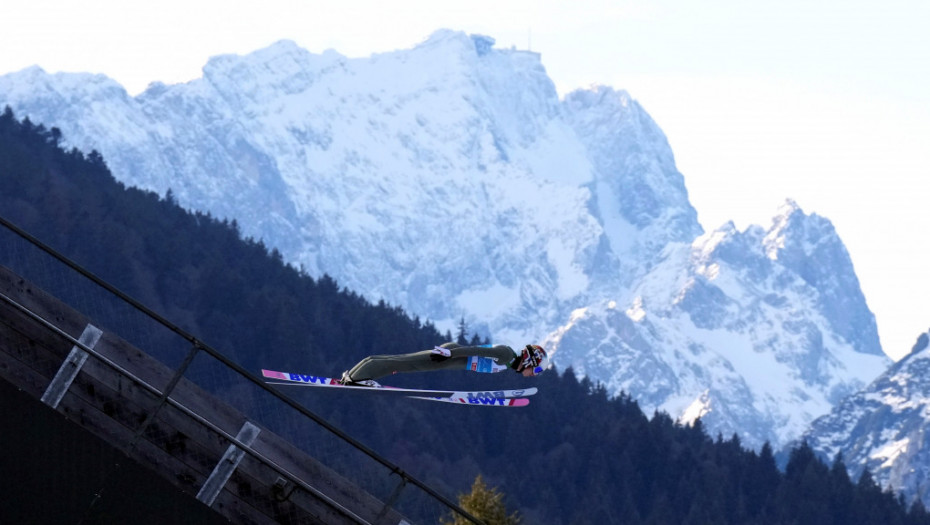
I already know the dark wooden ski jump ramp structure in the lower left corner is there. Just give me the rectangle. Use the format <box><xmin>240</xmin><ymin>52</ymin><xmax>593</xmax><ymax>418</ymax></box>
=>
<box><xmin>0</xmin><ymin>267</ymin><xmax>407</xmax><ymax>525</ymax></box>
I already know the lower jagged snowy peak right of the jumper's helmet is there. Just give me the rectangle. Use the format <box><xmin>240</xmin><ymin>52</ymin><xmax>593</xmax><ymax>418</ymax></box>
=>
<box><xmin>552</xmin><ymin>201</ymin><xmax>887</xmax><ymax>446</ymax></box>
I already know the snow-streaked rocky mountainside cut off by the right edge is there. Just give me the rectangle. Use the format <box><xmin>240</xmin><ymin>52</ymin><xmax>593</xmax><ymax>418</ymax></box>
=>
<box><xmin>800</xmin><ymin>333</ymin><xmax>930</xmax><ymax>501</ymax></box>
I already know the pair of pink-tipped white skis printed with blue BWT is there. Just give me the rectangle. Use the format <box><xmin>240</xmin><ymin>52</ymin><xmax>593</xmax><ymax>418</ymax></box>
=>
<box><xmin>262</xmin><ymin>369</ymin><xmax>536</xmax><ymax>407</ymax></box>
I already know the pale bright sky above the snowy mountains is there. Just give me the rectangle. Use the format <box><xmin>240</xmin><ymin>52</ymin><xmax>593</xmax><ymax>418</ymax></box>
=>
<box><xmin>0</xmin><ymin>0</ymin><xmax>930</xmax><ymax>358</ymax></box>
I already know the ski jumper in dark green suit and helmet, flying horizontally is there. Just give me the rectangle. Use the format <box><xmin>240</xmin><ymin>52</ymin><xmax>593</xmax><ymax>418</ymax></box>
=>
<box><xmin>340</xmin><ymin>343</ymin><xmax>549</xmax><ymax>386</ymax></box>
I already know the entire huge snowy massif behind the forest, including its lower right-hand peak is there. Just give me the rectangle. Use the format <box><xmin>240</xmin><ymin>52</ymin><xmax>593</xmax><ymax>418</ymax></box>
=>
<box><xmin>0</xmin><ymin>30</ymin><xmax>890</xmax><ymax>445</ymax></box>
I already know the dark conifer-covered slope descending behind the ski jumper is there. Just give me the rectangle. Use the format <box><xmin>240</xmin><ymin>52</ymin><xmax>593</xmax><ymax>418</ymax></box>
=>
<box><xmin>0</xmin><ymin>108</ymin><xmax>930</xmax><ymax>525</ymax></box>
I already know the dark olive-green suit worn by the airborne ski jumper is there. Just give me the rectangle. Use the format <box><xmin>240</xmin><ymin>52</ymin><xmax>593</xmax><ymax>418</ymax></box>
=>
<box><xmin>349</xmin><ymin>343</ymin><xmax>517</xmax><ymax>381</ymax></box>
